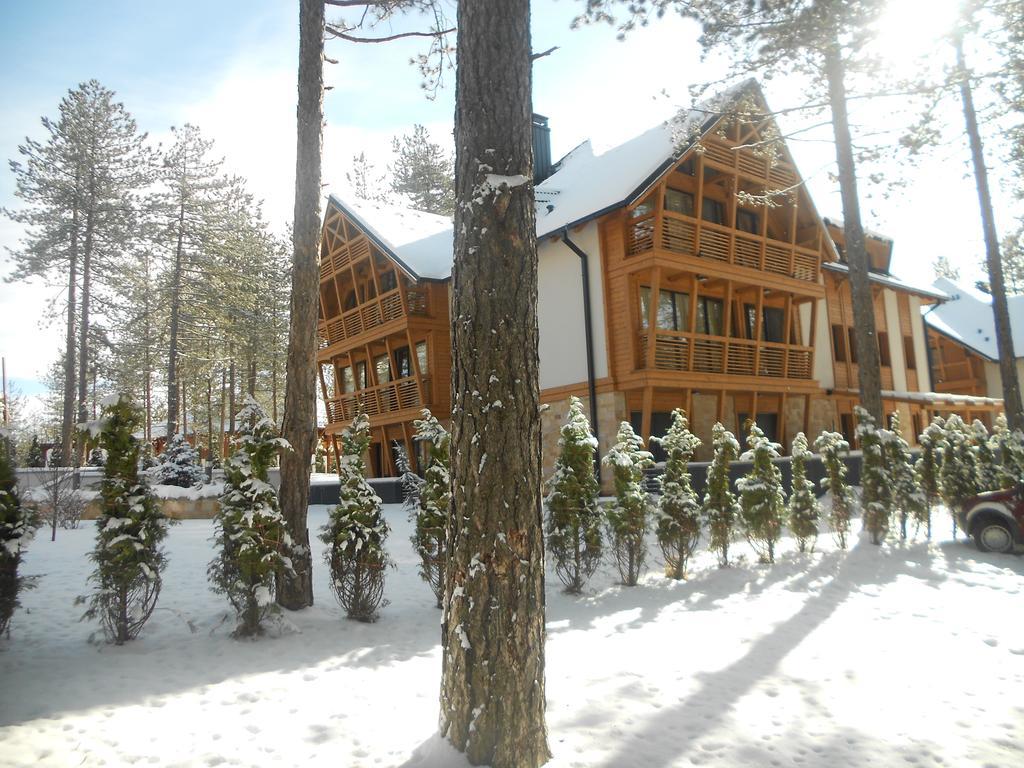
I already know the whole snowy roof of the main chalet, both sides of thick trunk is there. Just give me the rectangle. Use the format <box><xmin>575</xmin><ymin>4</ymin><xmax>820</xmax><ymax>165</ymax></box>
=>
<box><xmin>323</xmin><ymin>80</ymin><xmax>757</xmax><ymax>280</ymax></box>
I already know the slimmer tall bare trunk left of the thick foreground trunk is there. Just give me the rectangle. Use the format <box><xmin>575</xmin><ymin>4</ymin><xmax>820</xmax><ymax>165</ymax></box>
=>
<box><xmin>278</xmin><ymin>0</ymin><xmax>324</xmax><ymax>610</ymax></box>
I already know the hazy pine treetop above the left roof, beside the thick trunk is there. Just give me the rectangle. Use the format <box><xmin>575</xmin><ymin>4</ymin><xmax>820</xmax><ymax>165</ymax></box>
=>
<box><xmin>391</xmin><ymin>124</ymin><xmax>455</xmax><ymax>216</ymax></box>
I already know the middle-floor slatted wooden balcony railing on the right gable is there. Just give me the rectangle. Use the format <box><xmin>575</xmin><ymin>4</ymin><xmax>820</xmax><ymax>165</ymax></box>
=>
<box><xmin>637</xmin><ymin>331</ymin><xmax>812</xmax><ymax>379</ymax></box>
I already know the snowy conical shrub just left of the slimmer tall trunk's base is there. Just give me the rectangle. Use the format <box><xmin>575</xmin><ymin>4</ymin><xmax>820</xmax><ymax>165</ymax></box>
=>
<box><xmin>207</xmin><ymin>397</ymin><xmax>292</xmax><ymax>637</ymax></box>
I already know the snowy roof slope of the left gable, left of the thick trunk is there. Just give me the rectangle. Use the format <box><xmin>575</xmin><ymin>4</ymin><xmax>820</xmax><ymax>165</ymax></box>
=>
<box><xmin>331</xmin><ymin>195</ymin><xmax>455</xmax><ymax>280</ymax></box>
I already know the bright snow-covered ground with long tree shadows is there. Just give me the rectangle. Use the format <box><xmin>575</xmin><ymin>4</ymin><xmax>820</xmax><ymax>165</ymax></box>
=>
<box><xmin>0</xmin><ymin>506</ymin><xmax>1024</xmax><ymax>768</ymax></box>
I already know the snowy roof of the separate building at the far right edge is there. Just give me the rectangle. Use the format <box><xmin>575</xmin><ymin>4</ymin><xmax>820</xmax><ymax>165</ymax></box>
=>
<box><xmin>925</xmin><ymin>278</ymin><xmax>1024</xmax><ymax>360</ymax></box>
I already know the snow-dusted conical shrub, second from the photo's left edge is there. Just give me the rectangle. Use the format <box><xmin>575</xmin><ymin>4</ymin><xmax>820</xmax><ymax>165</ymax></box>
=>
<box><xmin>81</xmin><ymin>395</ymin><xmax>169</xmax><ymax>645</ymax></box>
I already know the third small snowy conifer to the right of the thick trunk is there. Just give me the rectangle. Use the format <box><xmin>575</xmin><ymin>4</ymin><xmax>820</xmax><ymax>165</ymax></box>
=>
<box><xmin>651</xmin><ymin>409</ymin><xmax>700</xmax><ymax>579</ymax></box>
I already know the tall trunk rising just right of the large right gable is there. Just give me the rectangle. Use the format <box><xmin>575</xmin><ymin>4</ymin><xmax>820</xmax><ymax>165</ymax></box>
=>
<box><xmin>825</xmin><ymin>40</ymin><xmax>885</xmax><ymax>425</ymax></box>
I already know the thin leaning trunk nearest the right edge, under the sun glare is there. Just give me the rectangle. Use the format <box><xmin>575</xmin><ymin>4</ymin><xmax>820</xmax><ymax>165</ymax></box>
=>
<box><xmin>954</xmin><ymin>35</ymin><xmax>1024</xmax><ymax>429</ymax></box>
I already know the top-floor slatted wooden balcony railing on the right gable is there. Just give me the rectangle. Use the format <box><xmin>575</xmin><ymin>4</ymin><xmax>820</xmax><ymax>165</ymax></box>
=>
<box><xmin>626</xmin><ymin>211</ymin><xmax>818</xmax><ymax>283</ymax></box>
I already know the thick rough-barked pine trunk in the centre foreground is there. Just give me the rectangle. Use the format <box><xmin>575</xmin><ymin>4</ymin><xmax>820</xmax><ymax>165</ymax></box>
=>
<box><xmin>440</xmin><ymin>0</ymin><xmax>549</xmax><ymax>768</ymax></box>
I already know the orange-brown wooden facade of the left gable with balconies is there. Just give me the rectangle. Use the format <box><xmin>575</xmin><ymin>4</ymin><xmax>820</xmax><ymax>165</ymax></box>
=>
<box><xmin>317</xmin><ymin>201</ymin><xmax>452</xmax><ymax>475</ymax></box>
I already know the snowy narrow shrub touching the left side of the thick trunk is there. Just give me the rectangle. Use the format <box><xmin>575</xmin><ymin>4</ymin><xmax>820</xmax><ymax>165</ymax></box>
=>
<box><xmin>411</xmin><ymin>409</ymin><xmax>452</xmax><ymax>608</ymax></box>
